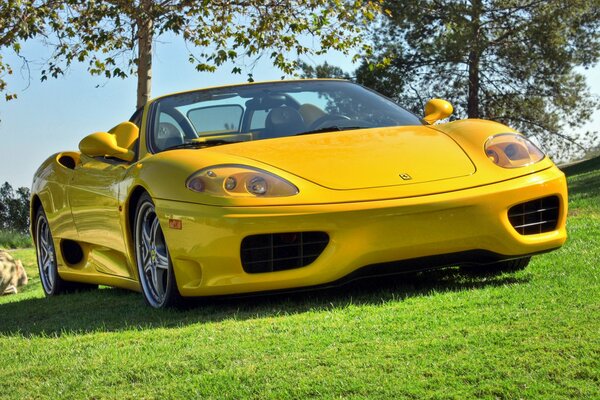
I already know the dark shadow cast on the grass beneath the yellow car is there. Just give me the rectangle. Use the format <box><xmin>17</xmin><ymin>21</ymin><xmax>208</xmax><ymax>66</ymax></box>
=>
<box><xmin>0</xmin><ymin>268</ymin><xmax>529</xmax><ymax>337</ymax></box>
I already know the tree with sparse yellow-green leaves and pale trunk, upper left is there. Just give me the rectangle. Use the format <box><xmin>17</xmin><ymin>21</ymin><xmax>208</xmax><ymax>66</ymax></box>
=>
<box><xmin>0</xmin><ymin>0</ymin><xmax>383</xmax><ymax>107</ymax></box>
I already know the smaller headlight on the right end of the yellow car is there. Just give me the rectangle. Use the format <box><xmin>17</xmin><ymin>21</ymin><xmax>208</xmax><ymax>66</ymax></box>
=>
<box><xmin>485</xmin><ymin>133</ymin><xmax>545</xmax><ymax>168</ymax></box>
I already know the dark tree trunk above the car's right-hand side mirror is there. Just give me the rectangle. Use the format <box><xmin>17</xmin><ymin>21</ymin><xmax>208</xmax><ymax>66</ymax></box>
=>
<box><xmin>467</xmin><ymin>0</ymin><xmax>483</xmax><ymax>118</ymax></box>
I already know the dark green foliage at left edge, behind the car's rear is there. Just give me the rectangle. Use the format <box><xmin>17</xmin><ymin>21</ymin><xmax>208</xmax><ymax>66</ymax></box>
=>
<box><xmin>0</xmin><ymin>182</ymin><xmax>30</xmax><ymax>233</ymax></box>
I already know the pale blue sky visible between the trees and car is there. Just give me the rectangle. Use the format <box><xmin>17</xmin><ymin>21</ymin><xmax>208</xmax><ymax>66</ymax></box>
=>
<box><xmin>0</xmin><ymin>34</ymin><xmax>600</xmax><ymax>187</ymax></box>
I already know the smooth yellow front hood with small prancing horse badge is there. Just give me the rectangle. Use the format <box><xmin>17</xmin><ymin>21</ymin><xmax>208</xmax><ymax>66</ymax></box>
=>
<box><xmin>211</xmin><ymin>126</ymin><xmax>475</xmax><ymax>190</ymax></box>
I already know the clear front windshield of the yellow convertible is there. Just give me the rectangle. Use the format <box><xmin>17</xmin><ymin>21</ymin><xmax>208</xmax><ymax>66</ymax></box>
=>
<box><xmin>150</xmin><ymin>80</ymin><xmax>422</xmax><ymax>152</ymax></box>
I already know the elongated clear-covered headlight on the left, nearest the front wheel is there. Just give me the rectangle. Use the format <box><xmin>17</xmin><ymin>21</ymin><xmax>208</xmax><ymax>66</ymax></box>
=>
<box><xmin>185</xmin><ymin>165</ymin><xmax>298</xmax><ymax>197</ymax></box>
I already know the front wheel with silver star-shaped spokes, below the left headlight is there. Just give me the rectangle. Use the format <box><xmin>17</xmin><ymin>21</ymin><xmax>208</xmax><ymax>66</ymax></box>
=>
<box><xmin>133</xmin><ymin>193</ymin><xmax>181</xmax><ymax>308</ymax></box>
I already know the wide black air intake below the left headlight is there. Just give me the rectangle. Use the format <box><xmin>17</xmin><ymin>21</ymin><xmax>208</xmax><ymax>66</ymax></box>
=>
<box><xmin>241</xmin><ymin>232</ymin><xmax>329</xmax><ymax>274</ymax></box>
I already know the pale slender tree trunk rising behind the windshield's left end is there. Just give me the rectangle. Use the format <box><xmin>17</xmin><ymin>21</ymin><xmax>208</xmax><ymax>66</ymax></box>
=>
<box><xmin>136</xmin><ymin>0</ymin><xmax>154</xmax><ymax>108</ymax></box>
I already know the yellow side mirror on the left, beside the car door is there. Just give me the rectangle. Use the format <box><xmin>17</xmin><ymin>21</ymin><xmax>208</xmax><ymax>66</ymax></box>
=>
<box><xmin>79</xmin><ymin>122</ymin><xmax>139</xmax><ymax>162</ymax></box>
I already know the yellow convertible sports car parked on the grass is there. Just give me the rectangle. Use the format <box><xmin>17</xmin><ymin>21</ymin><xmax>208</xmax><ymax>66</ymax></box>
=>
<box><xmin>31</xmin><ymin>80</ymin><xmax>567</xmax><ymax>307</ymax></box>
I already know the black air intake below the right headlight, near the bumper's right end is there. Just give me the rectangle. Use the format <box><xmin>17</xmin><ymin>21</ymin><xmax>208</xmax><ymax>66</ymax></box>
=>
<box><xmin>508</xmin><ymin>196</ymin><xmax>560</xmax><ymax>235</ymax></box>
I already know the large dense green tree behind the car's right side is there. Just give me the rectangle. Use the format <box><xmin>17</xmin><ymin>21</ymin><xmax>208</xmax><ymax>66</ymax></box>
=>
<box><xmin>357</xmin><ymin>0</ymin><xmax>600</xmax><ymax>159</ymax></box>
